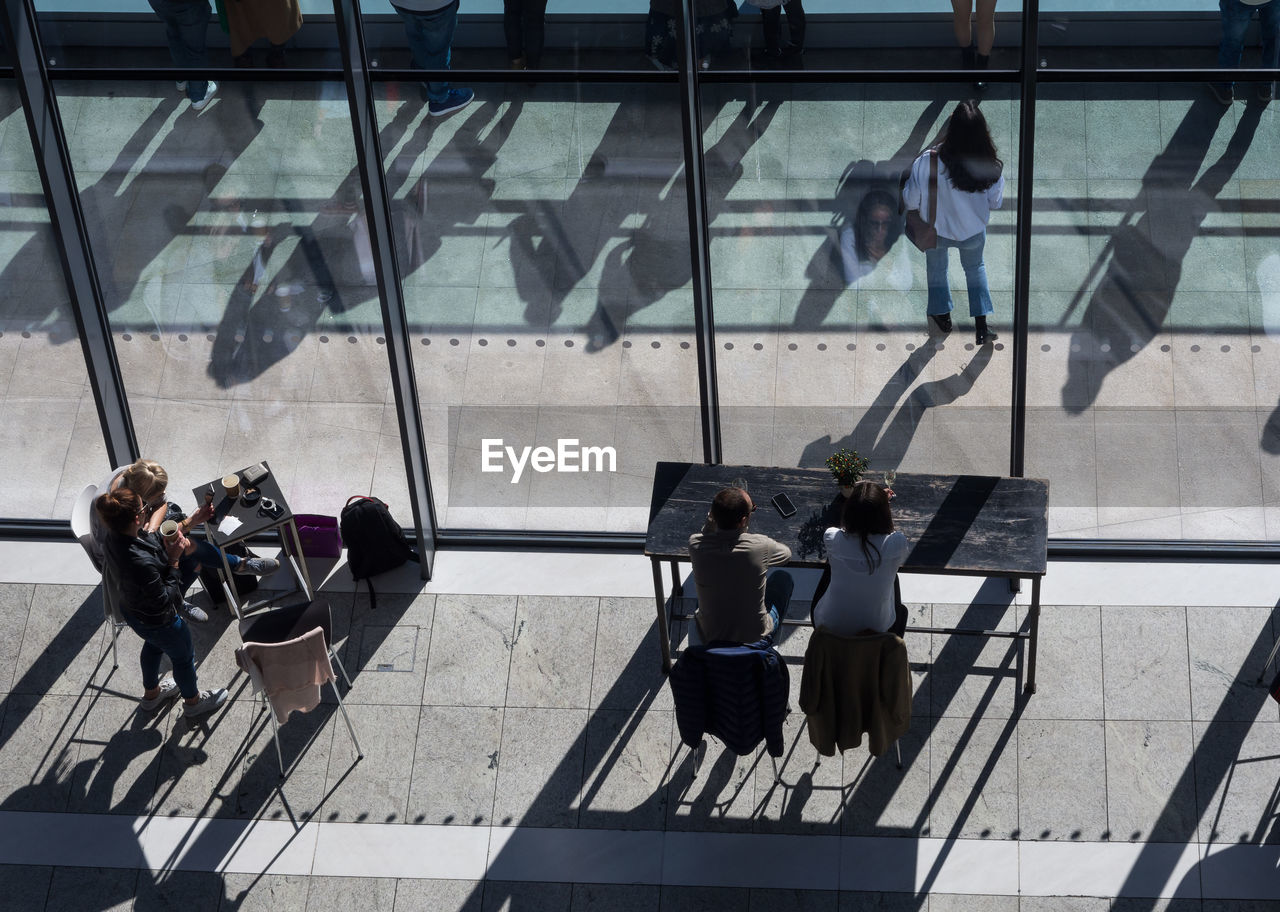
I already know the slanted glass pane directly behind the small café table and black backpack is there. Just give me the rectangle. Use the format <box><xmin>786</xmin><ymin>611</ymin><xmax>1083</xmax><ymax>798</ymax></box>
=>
<box><xmin>56</xmin><ymin>76</ymin><xmax>410</xmax><ymax>523</ymax></box>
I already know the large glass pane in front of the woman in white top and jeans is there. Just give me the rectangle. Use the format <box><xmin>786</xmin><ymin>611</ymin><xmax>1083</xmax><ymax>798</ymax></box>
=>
<box><xmin>703</xmin><ymin>86</ymin><xmax>1018</xmax><ymax>484</ymax></box>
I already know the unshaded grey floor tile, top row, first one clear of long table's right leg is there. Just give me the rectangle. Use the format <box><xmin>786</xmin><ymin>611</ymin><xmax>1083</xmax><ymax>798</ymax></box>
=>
<box><xmin>1102</xmin><ymin>606</ymin><xmax>1190</xmax><ymax>721</ymax></box>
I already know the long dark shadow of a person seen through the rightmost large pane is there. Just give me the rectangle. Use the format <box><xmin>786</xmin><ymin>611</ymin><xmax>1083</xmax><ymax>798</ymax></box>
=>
<box><xmin>1061</xmin><ymin>94</ymin><xmax>1266</xmax><ymax>415</ymax></box>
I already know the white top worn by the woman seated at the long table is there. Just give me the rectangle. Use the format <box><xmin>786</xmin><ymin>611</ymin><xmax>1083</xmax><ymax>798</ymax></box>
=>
<box><xmin>813</xmin><ymin>526</ymin><xmax>911</xmax><ymax>637</ymax></box>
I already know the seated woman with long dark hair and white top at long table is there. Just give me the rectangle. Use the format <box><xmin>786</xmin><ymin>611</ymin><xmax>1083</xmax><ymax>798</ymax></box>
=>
<box><xmin>813</xmin><ymin>482</ymin><xmax>911</xmax><ymax>637</ymax></box>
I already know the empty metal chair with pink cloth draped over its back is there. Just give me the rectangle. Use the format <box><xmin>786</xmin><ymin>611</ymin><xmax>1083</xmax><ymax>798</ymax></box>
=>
<box><xmin>236</xmin><ymin>602</ymin><xmax>365</xmax><ymax>779</ymax></box>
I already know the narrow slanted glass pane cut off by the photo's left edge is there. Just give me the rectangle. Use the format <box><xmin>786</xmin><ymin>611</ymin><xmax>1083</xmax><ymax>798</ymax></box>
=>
<box><xmin>0</xmin><ymin>81</ymin><xmax>109</xmax><ymax>519</ymax></box>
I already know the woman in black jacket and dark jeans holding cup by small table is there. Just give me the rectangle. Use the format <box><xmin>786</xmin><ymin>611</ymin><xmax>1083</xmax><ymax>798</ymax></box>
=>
<box><xmin>95</xmin><ymin>488</ymin><xmax>227</xmax><ymax>719</ymax></box>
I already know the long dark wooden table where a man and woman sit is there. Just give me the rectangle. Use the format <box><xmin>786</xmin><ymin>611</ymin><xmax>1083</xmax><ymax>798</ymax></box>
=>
<box><xmin>644</xmin><ymin>462</ymin><xmax>1048</xmax><ymax>693</ymax></box>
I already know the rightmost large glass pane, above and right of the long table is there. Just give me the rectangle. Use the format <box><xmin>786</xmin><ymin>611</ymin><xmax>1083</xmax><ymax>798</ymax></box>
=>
<box><xmin>1027</xmin><ymin>85</ymin><xmax>1280</xmax><ymax>541</ymax></box>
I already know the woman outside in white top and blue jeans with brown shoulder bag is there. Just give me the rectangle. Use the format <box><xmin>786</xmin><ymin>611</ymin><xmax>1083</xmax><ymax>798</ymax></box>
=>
<box><xmin>902</xmin><ymin>101</ymin><xmax>1005</xmax><ymax>346</ymax></box>
